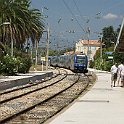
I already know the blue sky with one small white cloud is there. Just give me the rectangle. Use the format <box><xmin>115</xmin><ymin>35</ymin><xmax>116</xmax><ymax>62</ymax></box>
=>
<box><xmin>31</xmin><ymin>0</ymin><xmax>124</xmax><ymax>49</ymax></box>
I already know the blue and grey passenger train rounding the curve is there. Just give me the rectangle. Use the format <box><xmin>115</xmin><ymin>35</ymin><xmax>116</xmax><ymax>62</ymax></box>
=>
<box><xmin>49</xmin><ymin>54</ymin><xmax>88</xmax><ymax>73</ymax></box>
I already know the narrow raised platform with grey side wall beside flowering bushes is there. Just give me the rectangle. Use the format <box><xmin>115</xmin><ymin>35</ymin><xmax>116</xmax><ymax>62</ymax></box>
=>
<box><xmin>0</xmin><ymin>71</ymin><xmax>53</xmax><ymax>91</ymax></box>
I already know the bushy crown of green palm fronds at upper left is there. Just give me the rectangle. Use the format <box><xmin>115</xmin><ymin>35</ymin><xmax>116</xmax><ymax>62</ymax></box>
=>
<box><xmin>0</xmin><ymin>0</ymin><xmax>44</xmax><ymax>52</ymax></box>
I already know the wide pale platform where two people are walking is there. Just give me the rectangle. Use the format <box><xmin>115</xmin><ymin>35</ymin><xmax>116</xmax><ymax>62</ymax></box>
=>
<box><xmin>45</xmin><ymin>70</ymin><xmax>124</xmax><ymax>124</ymax></box>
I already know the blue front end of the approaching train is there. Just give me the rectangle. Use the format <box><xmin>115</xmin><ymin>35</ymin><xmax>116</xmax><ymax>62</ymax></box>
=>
<box><xmin>74</xmin><ymin>54</ymin><xmax>88</xmax><ymax>73</ymax></box>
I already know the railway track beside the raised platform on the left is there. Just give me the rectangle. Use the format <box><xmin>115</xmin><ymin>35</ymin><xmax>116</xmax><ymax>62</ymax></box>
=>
<box><xmin>0</xmin><ymin>70</ymin><xmax>65</xmax><ymax>104</ymax></box>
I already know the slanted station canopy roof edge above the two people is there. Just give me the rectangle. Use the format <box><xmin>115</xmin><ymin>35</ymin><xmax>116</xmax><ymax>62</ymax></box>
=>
<box><xmin>115</xmin><ymin>19</ymin><xmax>124</xmax><ymax>52</ymax></box>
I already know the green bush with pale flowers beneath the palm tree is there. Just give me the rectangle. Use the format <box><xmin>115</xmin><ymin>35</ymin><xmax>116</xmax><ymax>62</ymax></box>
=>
<box><xmin>0</xmin><ymin>54</ymin><xmax>32</xmax><ymax>75</ymax></box>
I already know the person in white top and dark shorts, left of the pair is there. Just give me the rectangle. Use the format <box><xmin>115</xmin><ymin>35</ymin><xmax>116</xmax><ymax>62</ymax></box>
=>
<box><xmin>111</xmin><ymin>63</ymin><xmax>118</xmax><ymax>87</ymax></box>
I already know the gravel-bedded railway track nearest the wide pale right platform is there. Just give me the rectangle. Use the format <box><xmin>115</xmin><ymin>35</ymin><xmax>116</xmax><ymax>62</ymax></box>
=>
<box><xmin>0</xmin><ymin>68</ymin><xmax>96</xmax><ymax>124</ymax></box>
